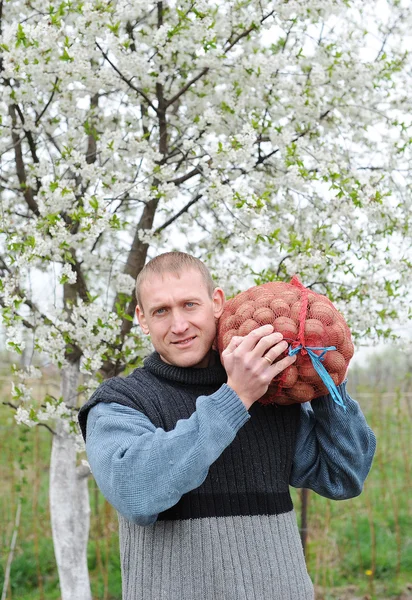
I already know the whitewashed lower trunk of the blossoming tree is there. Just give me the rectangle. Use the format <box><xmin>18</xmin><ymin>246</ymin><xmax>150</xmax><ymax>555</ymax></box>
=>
<box><xmin>50</xmin><ymin>363</ymin><xmax>92</xmax><ymax>600</ymax></box>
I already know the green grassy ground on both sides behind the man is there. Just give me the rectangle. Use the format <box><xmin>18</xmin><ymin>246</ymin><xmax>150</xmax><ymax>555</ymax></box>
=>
<box><xmin>0</xmin><ymin>382</ymin><xmax>412</xmax><ymax>600</ymax></box>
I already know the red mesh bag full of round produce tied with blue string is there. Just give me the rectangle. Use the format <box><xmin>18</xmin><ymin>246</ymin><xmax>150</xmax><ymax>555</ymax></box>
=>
<box><xmin>217</xmin><ymin>276</ymin><xmax>354</xmax><ymax>405</ymax></box>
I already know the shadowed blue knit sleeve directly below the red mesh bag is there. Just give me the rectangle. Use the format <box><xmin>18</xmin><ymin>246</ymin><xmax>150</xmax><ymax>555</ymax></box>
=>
<box><xmin>290</xmin><ymin>383</ymin><xmax>376</xmax><ymax>500</ymax></box>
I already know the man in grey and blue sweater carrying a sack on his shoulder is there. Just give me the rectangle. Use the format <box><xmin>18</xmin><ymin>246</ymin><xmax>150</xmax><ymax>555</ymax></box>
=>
<box><xmin>79</xmin><ymin>252</ymin><xmax>375</xmax><ymax>600</ymax></box>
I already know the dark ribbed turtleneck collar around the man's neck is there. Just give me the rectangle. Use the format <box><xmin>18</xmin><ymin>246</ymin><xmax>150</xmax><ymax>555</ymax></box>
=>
<box><xmin>144</xmin><ymin>352</ymin><xmax>227</xmax><ymax>386</ymax></box>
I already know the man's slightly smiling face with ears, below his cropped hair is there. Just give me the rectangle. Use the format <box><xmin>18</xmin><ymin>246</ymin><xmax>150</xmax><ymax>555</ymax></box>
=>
<box><xmin>136</xmin><ymin>269</ymin><xmax>225</xmax><ymax>367</ymax></box>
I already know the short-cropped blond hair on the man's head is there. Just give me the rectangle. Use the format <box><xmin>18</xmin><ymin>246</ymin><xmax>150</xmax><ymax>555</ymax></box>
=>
<box><xmin>136</xmin><ymin>252</ymin><xmax>216</xmax><ymax>308</ymax></box>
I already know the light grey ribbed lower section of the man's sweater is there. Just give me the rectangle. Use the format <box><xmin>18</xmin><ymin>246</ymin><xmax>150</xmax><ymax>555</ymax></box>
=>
<box><xmin>119</xmin><ymin>512</ymin><xmax>314</xmax><ymax>600</ymax></box>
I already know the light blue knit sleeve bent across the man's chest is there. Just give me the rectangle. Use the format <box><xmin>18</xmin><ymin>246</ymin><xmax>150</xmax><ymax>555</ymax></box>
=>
<box><xmin>86</xmin><ymin>384</ymin><xmax>250</xmax><ymax>525</ymax></box>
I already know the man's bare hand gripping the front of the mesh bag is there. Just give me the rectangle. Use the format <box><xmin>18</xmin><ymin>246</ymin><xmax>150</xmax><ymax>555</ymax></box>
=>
<box><xmin>222</xmin><ymin>325</ymin><xmax>296</xmax><ymax>409</ymax></box>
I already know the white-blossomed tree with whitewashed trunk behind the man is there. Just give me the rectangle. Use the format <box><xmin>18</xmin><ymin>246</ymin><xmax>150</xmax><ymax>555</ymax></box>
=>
<box><xmin>0</xmin><ymin>0</ymin><xmax>412</xmax><ymax>600</ymax></box>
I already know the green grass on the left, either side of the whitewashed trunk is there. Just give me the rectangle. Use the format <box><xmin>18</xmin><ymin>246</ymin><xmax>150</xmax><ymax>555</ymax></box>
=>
<box><xmin>0</xmin><ymin>390</ymin><xmax>121</xmax><ymax>600</ymax></box>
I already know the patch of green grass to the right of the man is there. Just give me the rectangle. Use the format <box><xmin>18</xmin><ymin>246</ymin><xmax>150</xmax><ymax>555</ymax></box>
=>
<box><xmin>294</xmin><ymin>386</ymin><xmax>412</xmax><ymax>600</ymax></box>
